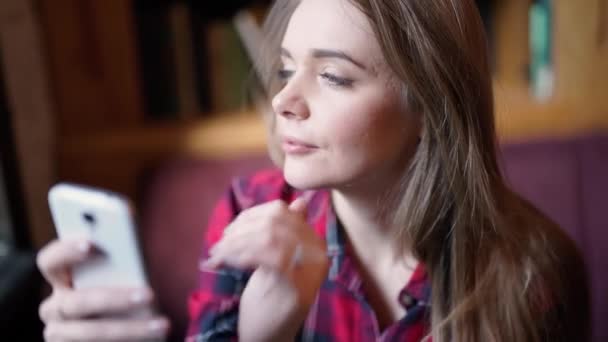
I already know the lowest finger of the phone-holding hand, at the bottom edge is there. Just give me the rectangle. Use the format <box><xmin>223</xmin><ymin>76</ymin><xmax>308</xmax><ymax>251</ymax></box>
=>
<box><xmin>44</xmin><ymin>317</ymin><xmax>169</xmax><ymax>342</ymax></box>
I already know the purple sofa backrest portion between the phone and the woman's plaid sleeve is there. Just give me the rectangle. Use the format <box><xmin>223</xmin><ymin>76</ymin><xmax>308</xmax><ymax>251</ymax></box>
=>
<box><xmin>140</xmin><ymin>156</ymin><xmax>271</xmax><ymax>341</ymax></box>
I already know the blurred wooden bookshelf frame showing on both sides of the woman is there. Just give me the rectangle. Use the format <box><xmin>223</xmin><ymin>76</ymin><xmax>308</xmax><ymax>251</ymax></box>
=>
<box><xmin>0</xmin><ymin>0</ymin><xmax>608</xmax><ymax>247</ymax></box>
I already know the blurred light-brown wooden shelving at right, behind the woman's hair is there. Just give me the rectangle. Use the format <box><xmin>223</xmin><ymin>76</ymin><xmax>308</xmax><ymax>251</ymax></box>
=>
<box><xmin>493</xmin><ymin>0</ymin><xmax>608</xmax><ymax>142</ymax></box>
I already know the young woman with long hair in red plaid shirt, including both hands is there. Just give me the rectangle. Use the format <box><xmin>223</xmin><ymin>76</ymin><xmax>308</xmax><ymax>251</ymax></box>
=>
<box><xmin>39</xmin><ymin>0</ymin><xmax>588</xmax><ymax>342</ymax></box>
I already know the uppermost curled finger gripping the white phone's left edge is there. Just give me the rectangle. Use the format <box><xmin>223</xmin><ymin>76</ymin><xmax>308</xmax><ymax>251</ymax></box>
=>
<box><xmin>36</xmin><ymin>239</ymin><xmax>91</xmax><ymax>288</ymax></box>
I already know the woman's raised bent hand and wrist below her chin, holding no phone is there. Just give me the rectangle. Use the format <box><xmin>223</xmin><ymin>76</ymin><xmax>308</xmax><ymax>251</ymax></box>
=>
<box><xmin>205</xmin><ymin>198</ymin><xmax>329</xmax><ymax>341</ymax></box>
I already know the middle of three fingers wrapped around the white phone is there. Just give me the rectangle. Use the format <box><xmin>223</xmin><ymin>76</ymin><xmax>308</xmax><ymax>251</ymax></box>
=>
<box><xmin>39</xmin><ymin>288</ymin><xmax>154</xmax><ymax>323</ymax></box>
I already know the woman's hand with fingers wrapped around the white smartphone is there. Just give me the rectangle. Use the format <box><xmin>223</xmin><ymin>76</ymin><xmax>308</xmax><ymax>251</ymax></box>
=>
<box><xmin>37</xmin><ymin>240</ymin><xmax>169</xmax><ymax>341</ymax></box>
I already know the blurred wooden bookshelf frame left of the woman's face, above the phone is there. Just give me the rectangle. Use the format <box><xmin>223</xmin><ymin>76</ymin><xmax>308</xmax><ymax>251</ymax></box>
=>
<box><xmin>38</xmin><ymin>0</ymin><xmax>265</xmax><ymax>196</ymax></box>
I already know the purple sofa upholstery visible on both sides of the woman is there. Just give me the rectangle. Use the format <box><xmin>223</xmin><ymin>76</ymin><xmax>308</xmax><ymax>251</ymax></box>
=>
<box><xmin>141</xmin><ymin>135</ymin><xmax>608</xmax><ymax>342</ymax></box>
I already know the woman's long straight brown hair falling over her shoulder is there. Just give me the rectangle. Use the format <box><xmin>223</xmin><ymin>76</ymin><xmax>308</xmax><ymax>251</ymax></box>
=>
<box><xmin>259</xmin><ymin>0</ymin><xmax>589</xmax><ymax>342</ymax></box>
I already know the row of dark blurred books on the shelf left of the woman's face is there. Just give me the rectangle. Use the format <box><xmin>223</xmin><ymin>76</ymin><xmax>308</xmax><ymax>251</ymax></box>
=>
<box><xmin>134</xmin><ymin>0</ymin><xmax>252</xmax><ymax>119</ymax></box>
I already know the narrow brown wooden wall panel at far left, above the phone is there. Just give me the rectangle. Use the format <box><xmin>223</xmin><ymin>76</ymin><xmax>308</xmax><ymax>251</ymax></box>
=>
<box><xmin>0</xmin><ymin>0</ymin><xmax>56</xmax><ymax>247</ymax></box>
